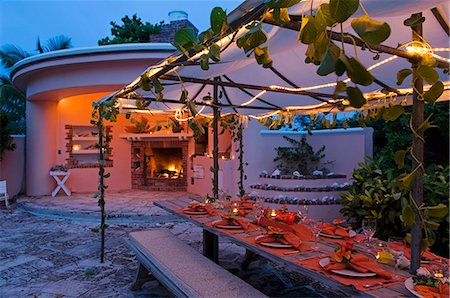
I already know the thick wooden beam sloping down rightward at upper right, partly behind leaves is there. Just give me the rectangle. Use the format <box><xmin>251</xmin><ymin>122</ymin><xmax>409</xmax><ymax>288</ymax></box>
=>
<box><xmin>264</xmin><ymin>14</ymin><xmax>450</xmax><ymax>70</ymax></box>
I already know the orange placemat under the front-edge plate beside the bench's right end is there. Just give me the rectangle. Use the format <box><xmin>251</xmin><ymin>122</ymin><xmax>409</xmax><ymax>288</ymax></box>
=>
<box><xmin>294</xmin><ymin>258</ymin><xmax>406</xmax><ymax>291</ymax></box>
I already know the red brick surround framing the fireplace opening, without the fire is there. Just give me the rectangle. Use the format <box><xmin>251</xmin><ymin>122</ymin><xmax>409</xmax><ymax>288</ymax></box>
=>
<box><xmin>131</xmin><ymin>138</ymin><xmax>189</xmax><ymax>191</ymax></box>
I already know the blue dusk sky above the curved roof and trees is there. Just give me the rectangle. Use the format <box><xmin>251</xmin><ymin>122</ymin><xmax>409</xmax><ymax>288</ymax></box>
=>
<box><xmin>0</xmin><ymin>0</ymin><xmax>242</xmax><ymax>73</ymax></box>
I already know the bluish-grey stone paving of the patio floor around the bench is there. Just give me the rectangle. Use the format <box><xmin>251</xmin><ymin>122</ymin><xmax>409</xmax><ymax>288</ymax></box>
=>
<box><xmin>0</xmin><ymin>191</ymin><xmax>342</xmax><ymax>298</ymax></box>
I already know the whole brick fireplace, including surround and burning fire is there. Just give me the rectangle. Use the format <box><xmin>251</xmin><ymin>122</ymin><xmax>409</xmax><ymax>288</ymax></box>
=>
<box><xmin>131</xmin><ymin>137</ymin><xmax>188</xmax><ymax>191</ymax></box>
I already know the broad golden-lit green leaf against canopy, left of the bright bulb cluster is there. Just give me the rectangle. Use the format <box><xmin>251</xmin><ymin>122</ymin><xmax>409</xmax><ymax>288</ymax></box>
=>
<box><xmin>352</xmin><ymin>16</ymin><xmax>391</xmax><ymax>44</ymax></box>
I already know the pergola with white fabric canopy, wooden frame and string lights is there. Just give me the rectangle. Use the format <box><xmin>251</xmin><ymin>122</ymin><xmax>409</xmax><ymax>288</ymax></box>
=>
<box><xmin>95</xmin><ymin>0</ymin><xmax>450</xmax><ymax>271</ymax></box>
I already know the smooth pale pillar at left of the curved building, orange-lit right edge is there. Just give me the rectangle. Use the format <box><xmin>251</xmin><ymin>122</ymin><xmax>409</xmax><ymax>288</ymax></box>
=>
<box><xmin>26</xmin><ymin>101</ymin><xmax>58</xmax><ymax>196</ymax></box>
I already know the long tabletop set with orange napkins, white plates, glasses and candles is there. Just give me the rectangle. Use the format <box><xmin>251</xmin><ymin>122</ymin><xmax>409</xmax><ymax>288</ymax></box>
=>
<box><xmin>171</xmin><ymin>201</ymin><xmax>448</xmax><ymax>298</ymax></box>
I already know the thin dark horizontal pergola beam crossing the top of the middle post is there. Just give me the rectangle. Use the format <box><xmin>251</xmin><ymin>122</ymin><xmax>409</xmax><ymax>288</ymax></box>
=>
<box><xmin>160</xmin><ymin>75</ymin><xmax>340</xmax><ymax>99</ymax></box>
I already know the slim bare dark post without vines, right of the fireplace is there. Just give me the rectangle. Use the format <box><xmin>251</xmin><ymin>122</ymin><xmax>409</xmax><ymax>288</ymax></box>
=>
<box><xmin>213</xmin><ymin>77</ymin><xmax>220</xmax><ymax>201</ymax></box>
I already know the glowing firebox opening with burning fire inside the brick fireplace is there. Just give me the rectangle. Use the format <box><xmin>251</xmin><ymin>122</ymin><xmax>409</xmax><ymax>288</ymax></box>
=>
<box><xmin>145</xmin><ymin>147</ymin><xmax>183</xmax><ymax>179</ymax></box>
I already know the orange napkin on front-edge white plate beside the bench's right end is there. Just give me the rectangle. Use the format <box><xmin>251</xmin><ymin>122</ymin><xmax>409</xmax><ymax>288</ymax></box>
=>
<box><xmin>325</xmin><ymin>254</ymin><xmax>393</xmax><ymax>279</ymax></box>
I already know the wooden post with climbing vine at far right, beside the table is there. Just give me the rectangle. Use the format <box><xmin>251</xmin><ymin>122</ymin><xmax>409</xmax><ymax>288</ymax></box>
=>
<box><xmin>410</xmin><ymin>13</ymin><xmax>424</xmax><ymax>274</ymax></box>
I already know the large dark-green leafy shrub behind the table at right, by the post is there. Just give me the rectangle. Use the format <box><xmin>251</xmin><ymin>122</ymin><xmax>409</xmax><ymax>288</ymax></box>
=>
<box><xmin>341</xmin><ymin>156</ymin><xmax>449</xmax><ymax>256</ymax></box>
